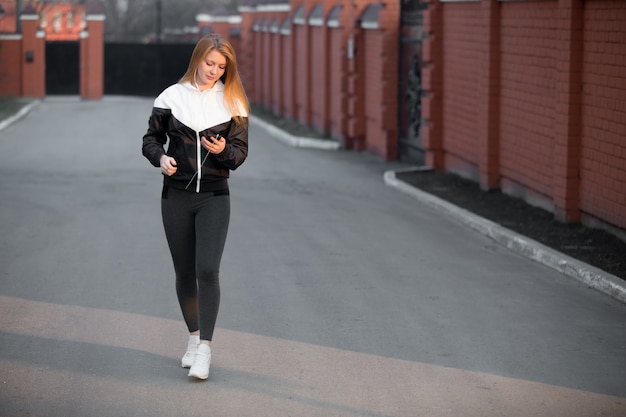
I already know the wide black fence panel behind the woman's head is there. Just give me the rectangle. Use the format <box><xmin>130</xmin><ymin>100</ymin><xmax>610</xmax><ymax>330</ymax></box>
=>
<box><xmin>104</xmin><ymin>43</ymin><xmax>195</xmax><ymax>97</ymax></box>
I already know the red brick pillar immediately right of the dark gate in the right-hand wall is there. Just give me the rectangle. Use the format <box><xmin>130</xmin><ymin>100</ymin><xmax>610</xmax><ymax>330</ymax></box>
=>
<box><xmin>420</xmin><ymin>0</ymin><xmax>444</xmax><ymax>170</ymax></box>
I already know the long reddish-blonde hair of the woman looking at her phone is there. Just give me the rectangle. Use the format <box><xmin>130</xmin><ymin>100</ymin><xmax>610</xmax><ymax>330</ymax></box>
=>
<box><xmin>179</xmin><ymin>33</ymin><xmax>250</xmax><ymax>124</ymax></box>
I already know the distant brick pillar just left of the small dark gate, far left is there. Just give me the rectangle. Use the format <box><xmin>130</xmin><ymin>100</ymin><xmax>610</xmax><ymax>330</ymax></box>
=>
<box><xmin>20</xmin><ymin>12</ymin><xmax>46</xmax><ymax>98</ymax></box>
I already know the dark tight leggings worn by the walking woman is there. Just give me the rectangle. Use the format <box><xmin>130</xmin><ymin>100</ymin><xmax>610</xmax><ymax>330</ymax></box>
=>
<box><xmin>161</xmin><ymin>187</ymin><xmax>230</xmax><ymax>340</ymax></box>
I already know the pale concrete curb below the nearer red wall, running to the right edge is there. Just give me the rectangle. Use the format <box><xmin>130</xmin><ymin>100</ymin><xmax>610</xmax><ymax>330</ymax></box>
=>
<box><xmin>384</xmin><ymin>168</ymin><xmax>626</xmax><ymax>303</ymax></box>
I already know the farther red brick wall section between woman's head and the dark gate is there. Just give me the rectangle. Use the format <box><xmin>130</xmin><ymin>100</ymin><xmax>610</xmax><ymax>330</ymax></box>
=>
<box><xmin>240</xmin><ymin>0</ymin><xmax>376</xmax><ymax>151</ymax></box>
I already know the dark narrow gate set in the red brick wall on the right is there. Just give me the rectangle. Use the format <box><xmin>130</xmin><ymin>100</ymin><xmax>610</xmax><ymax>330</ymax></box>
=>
<box><xmin>398</xmin><ymin>0</ymin><xmax>427</xmax><ymax>165</ymax></box>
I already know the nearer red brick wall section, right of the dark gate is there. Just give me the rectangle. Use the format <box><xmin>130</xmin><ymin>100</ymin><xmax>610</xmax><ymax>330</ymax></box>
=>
<box><xmin>421</xmin><ymin>0</ymin><xmax>626</xmax><ymax>234</ymax></box>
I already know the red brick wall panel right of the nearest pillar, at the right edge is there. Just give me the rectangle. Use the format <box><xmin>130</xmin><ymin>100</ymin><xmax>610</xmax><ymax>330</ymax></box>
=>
<box><xmin>580</xmin><ymin>0</ymin><xmax>626</xmax><ymax>229</ymax></box>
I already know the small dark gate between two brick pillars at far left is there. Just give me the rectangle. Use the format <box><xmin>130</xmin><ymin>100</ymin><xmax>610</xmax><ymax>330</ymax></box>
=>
<box><xmin>45</xmin><ymin>41</ymin><xmax>80</xmax><ymax>95</ymax></box>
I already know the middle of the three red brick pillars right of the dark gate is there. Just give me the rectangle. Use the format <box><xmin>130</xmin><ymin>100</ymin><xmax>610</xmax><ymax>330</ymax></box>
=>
<box><xmin>477</xmin><ymin>0</ymin><xmax>500</xmax><ymax>190</ymax></box>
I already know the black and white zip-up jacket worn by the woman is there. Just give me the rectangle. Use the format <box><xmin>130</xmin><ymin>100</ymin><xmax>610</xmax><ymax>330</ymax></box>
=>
<box><xmin>142</xmin><ymin>80</ymin><xmax>248</xmax><ymax>192</ymax></box>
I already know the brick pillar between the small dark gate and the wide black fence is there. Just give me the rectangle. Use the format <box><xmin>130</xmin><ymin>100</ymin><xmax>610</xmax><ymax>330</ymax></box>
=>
<box><xmin>80</xmin><ymin>9</ymin><xmax>105</xmax><ymax>100</ymax></box>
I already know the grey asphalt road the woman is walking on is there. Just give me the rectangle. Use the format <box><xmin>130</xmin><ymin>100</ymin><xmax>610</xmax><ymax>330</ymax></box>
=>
<box><xmin>0</xmin><ymin>97</ymin><xmax>626</xmax><ymax>417</ymax></box>
